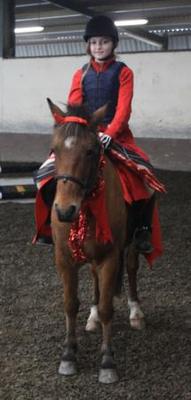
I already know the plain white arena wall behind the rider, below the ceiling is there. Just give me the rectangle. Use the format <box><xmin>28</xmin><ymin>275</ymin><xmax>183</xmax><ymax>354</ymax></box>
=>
<box><xmin>0</xmin><ymin>52</ymin><xmax>191</xmax><ymax>138</ymax></box>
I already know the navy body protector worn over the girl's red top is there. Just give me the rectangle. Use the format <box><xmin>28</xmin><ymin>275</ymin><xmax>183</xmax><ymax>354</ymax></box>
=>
<box><xmin>82</xmin><ymin>61</ymin><xmax>126</xmax><ymax>125</ymax></box>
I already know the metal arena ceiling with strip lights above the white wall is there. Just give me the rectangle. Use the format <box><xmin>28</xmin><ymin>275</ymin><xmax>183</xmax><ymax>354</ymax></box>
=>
<box><xmin>15</xmin><ymin>0</ymin><xmax>191</xmax><ymax>51</ymax></box>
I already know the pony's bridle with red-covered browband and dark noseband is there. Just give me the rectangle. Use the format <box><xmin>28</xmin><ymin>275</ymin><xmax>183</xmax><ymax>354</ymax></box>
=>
<box><xmin>54</xmin><ymin>113</ymin><xmax>101</xmax><ymax>196</ymax></box>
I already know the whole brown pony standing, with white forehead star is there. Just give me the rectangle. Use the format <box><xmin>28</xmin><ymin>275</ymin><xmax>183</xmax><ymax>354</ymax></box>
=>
<box><xmin>48</xmin><ymin>99</ymin><xmax>144</xmax><ymax>383</ymax></box>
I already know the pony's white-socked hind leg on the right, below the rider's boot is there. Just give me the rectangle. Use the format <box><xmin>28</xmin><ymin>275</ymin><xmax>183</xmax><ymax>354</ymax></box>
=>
<box><xmin>127</xmin><ymin>244</ymin><xmax>145</xmax><ymax>330</ymax></box>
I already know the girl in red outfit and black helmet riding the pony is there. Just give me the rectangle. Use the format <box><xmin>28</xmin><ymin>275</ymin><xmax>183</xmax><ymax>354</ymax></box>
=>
<box><xmin>36</xmin><ymin>15</ymin><xmax>164</xmax><ymax>260</ymax></box>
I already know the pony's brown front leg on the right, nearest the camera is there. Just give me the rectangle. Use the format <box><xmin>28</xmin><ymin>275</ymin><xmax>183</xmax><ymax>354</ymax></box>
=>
<box><xmin>98</xmin><ymin>256</ymin><xmax>118</xmax><ymax>383</ymax></box>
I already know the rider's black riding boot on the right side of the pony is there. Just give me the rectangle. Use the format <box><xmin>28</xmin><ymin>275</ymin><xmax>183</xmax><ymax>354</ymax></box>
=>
<box><xmin>134</xmin><ymin>193</ymin><xmax>156</xmax><ymax>254</ymax></box>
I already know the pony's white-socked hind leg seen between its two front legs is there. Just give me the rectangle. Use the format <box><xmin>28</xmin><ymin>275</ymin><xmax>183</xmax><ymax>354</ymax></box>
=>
<box><xmin>86</xmin><ymin>265</ymin><xmax>100</xmax><ymax>332</ymax></box>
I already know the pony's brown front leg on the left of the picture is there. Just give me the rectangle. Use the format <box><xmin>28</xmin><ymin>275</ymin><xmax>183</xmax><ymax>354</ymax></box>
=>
<box><xmin>55</xmin><ymin>248</ymin><xmax>79</xmax><ymax>376</ymax></box>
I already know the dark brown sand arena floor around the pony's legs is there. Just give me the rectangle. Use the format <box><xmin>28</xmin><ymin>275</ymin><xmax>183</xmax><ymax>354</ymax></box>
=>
<box><xmin>0</xmin><ymin>171</ymin><xmax>191</xmax><ymax>400</ymax></box>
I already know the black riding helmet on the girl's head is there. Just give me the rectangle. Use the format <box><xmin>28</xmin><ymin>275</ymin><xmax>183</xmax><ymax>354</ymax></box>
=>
<box><xmin>84</xmin><ymin>15</ymin><xmax>119</xmax><ymax>45</ymax></box>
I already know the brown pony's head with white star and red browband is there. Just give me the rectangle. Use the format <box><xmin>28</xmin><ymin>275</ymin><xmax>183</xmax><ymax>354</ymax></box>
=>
<box><xmin>47</xmin><ymin>99</ymin><xmax>106</xmax><ymax>222</ymax></box>
